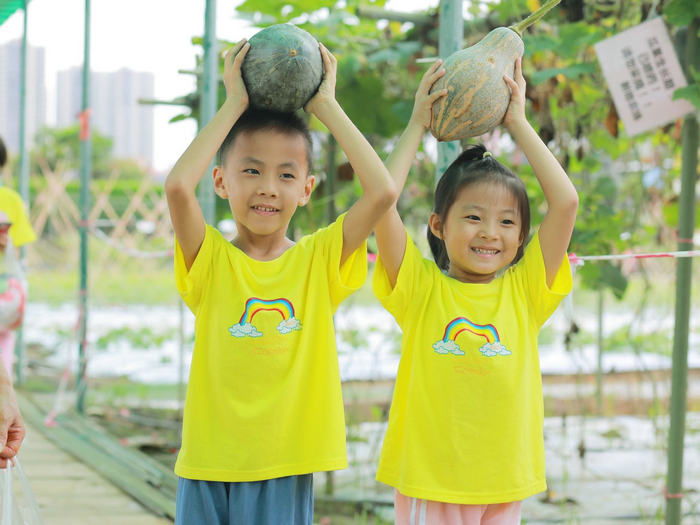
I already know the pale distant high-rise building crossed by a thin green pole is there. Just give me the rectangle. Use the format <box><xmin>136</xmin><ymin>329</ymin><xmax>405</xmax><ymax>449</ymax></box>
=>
<box><xmin>56</xmin><ymin>67</ymin><xmax>154</xmax><ymax>165</ymax></box>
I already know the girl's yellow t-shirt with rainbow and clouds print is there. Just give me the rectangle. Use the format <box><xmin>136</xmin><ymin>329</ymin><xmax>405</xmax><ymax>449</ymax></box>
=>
<box><xmin>373</xmin><ymin>230</ymin><xmax>571</xmax><ymax>504</ymax></box>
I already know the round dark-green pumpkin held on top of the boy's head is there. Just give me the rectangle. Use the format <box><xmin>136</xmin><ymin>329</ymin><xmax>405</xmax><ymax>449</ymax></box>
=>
<box><xmin>241</xmin><ymin>24</ymin><xmax>323</xmax><ymax>112</ymax></box>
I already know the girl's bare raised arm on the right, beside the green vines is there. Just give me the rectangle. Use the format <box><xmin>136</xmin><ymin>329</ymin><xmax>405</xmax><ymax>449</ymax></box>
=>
<box><xmin>503</xmin><ymin>59</ymin><xmax>578</xmax><ymax>286</ymax></box>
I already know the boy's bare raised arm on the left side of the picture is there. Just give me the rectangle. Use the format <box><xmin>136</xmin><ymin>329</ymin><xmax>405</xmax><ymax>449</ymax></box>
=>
<box><xmin>165</xmin><ymin>40</ymin><xmax>250</xmax><ymax>269</ymax></box>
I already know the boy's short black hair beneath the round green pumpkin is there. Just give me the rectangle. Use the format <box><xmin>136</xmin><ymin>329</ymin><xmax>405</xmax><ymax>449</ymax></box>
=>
<box><xmin>217</xmin><ymin>108</ymin><xmax>313</xmax><ymax>174</ymax></box>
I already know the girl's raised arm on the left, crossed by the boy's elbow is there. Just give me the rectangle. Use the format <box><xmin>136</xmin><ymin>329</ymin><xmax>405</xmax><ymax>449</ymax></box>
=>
<box><xmin>374</xmin><ymin>60</ymin><xmax>447</xmax><ymax>287</ymax></box>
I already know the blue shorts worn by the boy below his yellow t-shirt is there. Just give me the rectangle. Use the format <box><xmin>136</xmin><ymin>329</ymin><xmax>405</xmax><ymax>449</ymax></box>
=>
<box><xmin>175</xmin><ymin>474</ymin><xmax>314</xmax><ymax>525</ymax></box>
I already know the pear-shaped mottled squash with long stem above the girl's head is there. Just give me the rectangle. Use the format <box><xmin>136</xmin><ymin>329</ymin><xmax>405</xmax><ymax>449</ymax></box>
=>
<box><xmin>430</xmin><ymin>0</ymin><xmax>559</xmax><ymax>141</ymax></box>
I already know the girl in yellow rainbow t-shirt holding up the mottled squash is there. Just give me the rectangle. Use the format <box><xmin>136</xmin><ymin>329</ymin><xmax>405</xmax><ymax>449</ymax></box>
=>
<box><xmin>373</xmin><ymin>60</ymin><xmax>578</xmax><ymax>525</ymax></box>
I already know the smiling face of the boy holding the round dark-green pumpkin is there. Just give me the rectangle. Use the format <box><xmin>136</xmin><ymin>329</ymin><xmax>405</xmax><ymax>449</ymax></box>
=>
<box><xmin>214</xmin><ymin>130</ymin><xmax>315</xmax><ymax>236</ymax></box>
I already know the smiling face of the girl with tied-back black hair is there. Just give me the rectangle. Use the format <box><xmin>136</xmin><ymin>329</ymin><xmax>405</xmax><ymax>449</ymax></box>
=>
<box><xmin>429</xmin><ymin>183</ymin><xmax>523</xmax><ymax>283</ymax></box>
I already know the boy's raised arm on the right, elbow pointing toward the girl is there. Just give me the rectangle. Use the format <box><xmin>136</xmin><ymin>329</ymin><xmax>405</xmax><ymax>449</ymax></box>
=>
<box><xmin>305</xmin><ymin>44</ymin><xmax>397</xmax><ymax>265</ymax></box>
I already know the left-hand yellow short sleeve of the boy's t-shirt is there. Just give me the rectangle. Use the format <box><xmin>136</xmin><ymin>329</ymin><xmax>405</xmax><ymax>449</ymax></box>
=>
<box><xmin>174</xmin><ymin>225</ymin><xmax>218</xmax><ymax>315</ymax></box>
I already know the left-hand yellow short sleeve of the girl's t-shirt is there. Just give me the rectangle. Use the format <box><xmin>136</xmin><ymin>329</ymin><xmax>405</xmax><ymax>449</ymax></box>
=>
<box><xmin>372</xmin><ymin>232</ymin><xmax>434</xmax><ymax>323</ymax></box>
